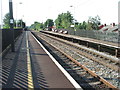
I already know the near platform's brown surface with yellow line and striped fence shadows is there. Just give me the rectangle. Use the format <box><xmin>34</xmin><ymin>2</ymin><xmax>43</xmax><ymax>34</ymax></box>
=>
<box><xmin>2</xmin><ymin>31</ymin><xmax>81</xmax><ymax>90</ymax></box>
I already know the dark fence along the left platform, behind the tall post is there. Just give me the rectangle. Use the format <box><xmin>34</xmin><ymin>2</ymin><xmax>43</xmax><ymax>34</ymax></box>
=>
<box><xmin>0</xmin><ymin>29</ymin><xmax>22</xmax><ymax>51</ymax></box>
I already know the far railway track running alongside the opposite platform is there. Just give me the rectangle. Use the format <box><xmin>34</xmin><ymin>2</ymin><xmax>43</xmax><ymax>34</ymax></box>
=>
<box><xmin>36</xmin><ymin>31</ymin><xmax>119</xmax><ymax>71</ymax></box>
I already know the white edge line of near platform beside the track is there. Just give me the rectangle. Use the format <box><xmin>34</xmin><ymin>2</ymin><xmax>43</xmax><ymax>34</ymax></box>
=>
<box><xmin>32</xmin><ymin>31</ymin><xmax>83</xmax><ymax>90</ymax></box>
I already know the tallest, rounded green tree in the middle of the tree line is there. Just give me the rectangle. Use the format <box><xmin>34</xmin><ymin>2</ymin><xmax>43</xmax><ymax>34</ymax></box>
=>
<box><xmin>55</xmin><ymin>11</ymin><xmax>73</xmax><ymax>29</ymax></box>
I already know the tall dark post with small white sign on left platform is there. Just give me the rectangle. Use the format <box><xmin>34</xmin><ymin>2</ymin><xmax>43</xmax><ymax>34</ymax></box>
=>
<box><xmin>9</xmin><ymin>0</ymin><xmax>15</xmax><ymax>52</ymax></box>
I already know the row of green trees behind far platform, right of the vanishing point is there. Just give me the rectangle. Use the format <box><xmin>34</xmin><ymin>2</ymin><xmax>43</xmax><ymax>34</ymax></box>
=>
<box><xmin>30</xmin><ymin>11</ymin><xmax>101</xmax><ymax>30</ymax></box>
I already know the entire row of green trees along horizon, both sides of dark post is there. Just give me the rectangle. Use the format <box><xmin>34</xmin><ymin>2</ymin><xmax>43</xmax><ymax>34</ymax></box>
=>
<box><xmin>3</xmin><ymin>11</ymin><xmax>101</xmax><ymax>30</ymax></box>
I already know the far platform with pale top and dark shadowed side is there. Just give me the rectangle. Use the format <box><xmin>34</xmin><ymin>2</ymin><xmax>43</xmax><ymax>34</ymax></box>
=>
<box><xmin>40</xmin><ymin>31</ymin><xmax>120</xmax><ymax>58</ymax></box>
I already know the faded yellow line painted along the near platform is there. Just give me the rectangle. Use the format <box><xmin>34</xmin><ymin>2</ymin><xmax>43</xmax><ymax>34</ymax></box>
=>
<box><xmin>26</xmin><ymin>31</ymin><xmax>34</xmax><ymax>90</ymax></box>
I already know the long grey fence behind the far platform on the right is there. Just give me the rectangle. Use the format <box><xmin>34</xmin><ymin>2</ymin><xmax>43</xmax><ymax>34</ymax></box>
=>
<box><xmin>67</xmin><ymin>29</ymin><xmax>120</xmax><ymax>43</ymax></box>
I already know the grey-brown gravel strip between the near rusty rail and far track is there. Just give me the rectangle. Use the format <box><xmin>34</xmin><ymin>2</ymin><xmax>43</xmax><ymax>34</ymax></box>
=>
<box><xmin>33</xmin><ymin>33</ymin><xmax>120</xmax><ymax>88</ymax></box>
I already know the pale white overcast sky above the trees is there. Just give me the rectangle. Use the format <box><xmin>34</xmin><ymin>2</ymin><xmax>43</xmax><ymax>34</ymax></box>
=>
<box><xmin>0</xmin><ymin>0</ymin><xmax>120</xmax><ymax>26</ymax></box>
